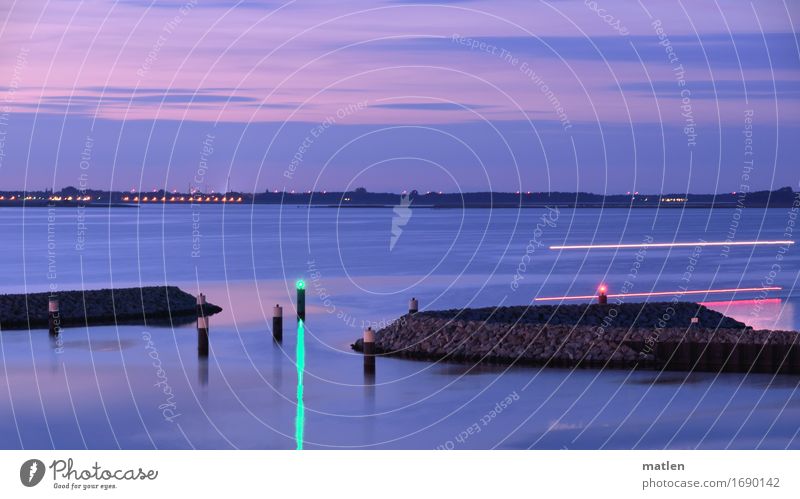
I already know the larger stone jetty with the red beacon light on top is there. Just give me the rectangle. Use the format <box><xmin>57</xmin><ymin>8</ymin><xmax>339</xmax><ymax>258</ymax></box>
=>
<box><xmin>352</xmin><ymin>302</ymin><xmax>800</xmax><ymax>374</ymax></box>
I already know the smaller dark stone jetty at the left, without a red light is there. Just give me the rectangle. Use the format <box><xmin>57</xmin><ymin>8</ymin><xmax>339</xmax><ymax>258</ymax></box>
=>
<box><xmin>0</xmin><ymin>286</ymin><xmax>222</xmax><ymax>330</ymax></box>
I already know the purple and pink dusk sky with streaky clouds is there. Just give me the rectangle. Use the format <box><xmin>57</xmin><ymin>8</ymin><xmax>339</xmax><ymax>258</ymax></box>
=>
<box><xmin>0</xmin><ymin>0</ymin><xmax>800</xmax><ymax>193</ymax></box>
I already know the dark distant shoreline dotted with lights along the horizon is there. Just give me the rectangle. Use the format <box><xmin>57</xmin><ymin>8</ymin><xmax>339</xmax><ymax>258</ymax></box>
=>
<box><xmin>0</xmin><ymin>187</ymin><xmax>800</xmax><ymax>209</ymax></box>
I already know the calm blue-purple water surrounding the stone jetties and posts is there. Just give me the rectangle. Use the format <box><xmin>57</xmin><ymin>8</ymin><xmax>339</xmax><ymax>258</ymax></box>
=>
<box><xmin>0</xmin><ymin>206</ymin><xmax>800</xmax><ymax>449</ymax></box>
